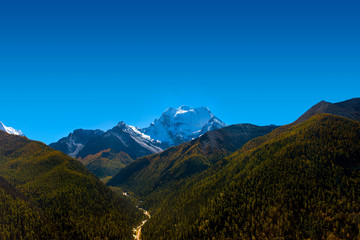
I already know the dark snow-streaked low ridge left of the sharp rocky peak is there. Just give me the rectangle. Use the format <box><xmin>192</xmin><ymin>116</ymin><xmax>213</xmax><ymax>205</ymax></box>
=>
<box><xmin>49</xmin><ymin>129</ymin><xmax>104</xmax><ymax>157</ymax></box>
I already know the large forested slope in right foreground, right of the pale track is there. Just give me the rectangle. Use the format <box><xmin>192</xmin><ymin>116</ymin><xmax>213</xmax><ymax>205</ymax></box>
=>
<box><xmin>137</xmin><ymin>114</ymin><xmax>360</xmax><ymax>239</ymax></box>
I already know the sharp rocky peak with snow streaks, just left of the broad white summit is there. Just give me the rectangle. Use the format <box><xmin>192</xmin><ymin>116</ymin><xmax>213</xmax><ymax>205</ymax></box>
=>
<box><xmin>77</xmin><ymin>122</ymin><xmax>162</xmax><ymax>159</ymax></box>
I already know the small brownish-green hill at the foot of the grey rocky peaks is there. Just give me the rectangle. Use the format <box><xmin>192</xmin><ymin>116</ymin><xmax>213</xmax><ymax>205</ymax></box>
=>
<box><xmin>79</xmin><ymin>149</ymin><xmax>133</xmax><ymax>178</ymax></box>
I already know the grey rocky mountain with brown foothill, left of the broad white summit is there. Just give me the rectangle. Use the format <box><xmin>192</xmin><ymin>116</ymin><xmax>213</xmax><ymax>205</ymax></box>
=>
<box><xmin>49</xmin><ymin>122</ymin><xmax>162</xmax><ymax>178</ymax></box>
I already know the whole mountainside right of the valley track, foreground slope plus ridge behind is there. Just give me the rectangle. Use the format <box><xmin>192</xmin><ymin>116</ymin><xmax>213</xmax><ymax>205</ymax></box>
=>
<box><xmin>107</xmin><ymin>99</ymin><xmax>360</xmax><ymax>239</ymax></box>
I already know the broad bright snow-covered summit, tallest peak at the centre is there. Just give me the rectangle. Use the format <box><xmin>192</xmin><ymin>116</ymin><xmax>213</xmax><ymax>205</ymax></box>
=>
<box><xmin>142</xmin><ymin>106</ymin><xmax>227</xmax><ymax>148</ymax></box>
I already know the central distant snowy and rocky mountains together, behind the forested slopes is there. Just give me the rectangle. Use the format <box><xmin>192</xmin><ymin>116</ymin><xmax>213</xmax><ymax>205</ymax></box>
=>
<box><xmin>49</xmin><ymin>106</ymin><xmax>226</xmax><ymax>177</ymax></box>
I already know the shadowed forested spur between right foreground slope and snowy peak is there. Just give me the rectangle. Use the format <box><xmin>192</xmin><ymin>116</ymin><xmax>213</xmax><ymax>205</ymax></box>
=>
<box><xmin>108</xmin><ymin>140</ymin><xmax>226</xmax><ymax>196</ymax></box>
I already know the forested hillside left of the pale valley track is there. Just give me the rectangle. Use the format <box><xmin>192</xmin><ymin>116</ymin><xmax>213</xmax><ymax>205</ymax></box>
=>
<box><xmin>0</xmin><ymin>131</ymin><xmax>142</xmax><ymax>240</ymax></box>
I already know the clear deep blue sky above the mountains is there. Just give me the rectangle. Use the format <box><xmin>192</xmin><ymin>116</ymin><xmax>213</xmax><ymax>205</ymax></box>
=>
<box><xmin>0</xmin><ymin>0</ymin><xmax>360</xmax><ymax>143</ymax></box>
